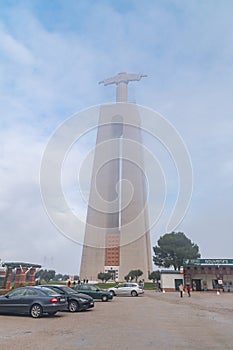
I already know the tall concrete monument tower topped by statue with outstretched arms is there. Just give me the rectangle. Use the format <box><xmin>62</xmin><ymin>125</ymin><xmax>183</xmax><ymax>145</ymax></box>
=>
<box><xmin>80</xmin><ymin>72</ymin><xmax>152</xmax><ymax>281</ymax></box>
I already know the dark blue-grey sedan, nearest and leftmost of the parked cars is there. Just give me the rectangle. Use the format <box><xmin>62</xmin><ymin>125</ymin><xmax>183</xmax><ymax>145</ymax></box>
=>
<box><xmin>0</xmin><ymin>286</ymin><xmax>68</xmax><ymax>318</ymax></box>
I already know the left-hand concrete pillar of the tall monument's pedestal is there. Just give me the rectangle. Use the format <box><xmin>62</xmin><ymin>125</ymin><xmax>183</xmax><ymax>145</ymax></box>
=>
<box><xmin>80</xmin><ymin>116</ymin><xmax>119</xmax><ymax>280</ymax></box>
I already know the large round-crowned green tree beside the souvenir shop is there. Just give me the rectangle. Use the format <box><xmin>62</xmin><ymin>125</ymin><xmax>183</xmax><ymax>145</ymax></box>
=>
<box><xmin>153</xmin><ymin>232</ymin><xmax>200</xmax><ymax>270</ymax></box>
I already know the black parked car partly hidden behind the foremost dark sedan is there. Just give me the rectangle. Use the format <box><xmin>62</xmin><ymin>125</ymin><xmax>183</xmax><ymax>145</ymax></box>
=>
<box><xmin>40</xmin><ymin>284</ymin><xmax>94</xmax><ymax>312</ymax></box>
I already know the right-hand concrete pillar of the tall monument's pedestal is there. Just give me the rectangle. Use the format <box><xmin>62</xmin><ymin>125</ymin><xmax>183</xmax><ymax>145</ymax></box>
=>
<box><xmin>119</xmin><ymin>105</ymin><xmax>152</xmax><ymax>280</ymax></box>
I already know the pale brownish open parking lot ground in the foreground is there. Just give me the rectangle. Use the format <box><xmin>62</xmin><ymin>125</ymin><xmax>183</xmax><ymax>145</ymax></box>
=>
<box><xmin>0</xmin><ymin>291</ymin><xmax>233</xmax><ymax>350</ymax></box>
